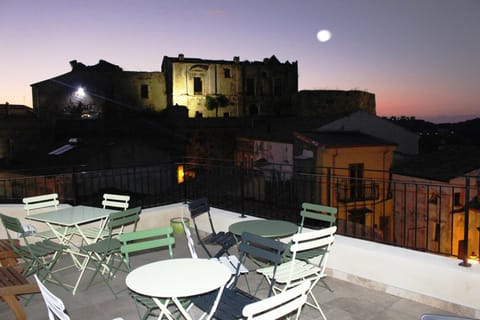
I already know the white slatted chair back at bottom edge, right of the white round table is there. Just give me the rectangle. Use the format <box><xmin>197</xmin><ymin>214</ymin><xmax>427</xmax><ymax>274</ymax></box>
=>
<box><xmin>243</xmin><ymin>281</ymin><xmax>310</xmax><ymax>320</ymax></box>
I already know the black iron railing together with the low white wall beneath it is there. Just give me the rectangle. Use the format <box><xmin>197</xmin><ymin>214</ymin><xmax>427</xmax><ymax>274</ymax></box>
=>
<box><xmin>0</xmin><ymin>162</ymin><xmax>480</xmax><ymax>317</ymax></box>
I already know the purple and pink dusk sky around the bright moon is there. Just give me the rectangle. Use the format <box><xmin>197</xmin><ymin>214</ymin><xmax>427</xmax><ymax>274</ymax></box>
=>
<box><xmin>0</xmin><ymin>0</ymin><xmax>480</xmax><ymax>122</ymax></box>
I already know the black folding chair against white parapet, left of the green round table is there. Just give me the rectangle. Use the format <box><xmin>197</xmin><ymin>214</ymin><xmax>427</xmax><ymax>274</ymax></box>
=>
<box><xmin>188</xmin><ymin>198</ymin><xmax>236</xmax><ymax>258</ymax></box>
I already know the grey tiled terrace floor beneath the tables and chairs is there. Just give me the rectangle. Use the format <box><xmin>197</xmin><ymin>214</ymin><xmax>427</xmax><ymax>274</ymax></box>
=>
<box><xmin>0</xmin><ymin>235</ymin><xmax>456</xmax><ymax>320</ymax></box>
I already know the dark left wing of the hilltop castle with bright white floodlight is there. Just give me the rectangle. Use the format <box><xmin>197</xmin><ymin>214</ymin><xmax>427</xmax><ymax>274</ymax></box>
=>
<box><xmin>31</xmin><ymin>60</ymin><xmax>167</xmax><ymax>120</ymax></box>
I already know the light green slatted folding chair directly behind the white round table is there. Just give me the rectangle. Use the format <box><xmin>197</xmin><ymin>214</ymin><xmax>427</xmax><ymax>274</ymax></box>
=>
<box><xmin>118</xmin><ymin>226</ymin><xmax>190</xmax><ymax>320</ymax></box>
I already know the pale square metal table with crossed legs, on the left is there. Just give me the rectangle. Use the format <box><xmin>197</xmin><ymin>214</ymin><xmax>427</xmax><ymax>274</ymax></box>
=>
<box><xmin>26</xmin><ymin>206</ymin><xmax>115</xmax><ymax>294</ymax></box>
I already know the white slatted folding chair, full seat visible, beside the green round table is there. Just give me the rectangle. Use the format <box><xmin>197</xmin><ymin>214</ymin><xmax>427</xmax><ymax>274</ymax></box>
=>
<box><xmin>257</xmin><ymin>226</ymin><xmax>337</xmax><ymax>320</ymax></box>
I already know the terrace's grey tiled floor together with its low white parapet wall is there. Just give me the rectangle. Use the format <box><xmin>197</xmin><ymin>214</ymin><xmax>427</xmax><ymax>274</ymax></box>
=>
<box><xmin>0</xmin><ymin>204</ymin><xmax>480</xmax><ymax>320</ymax></box>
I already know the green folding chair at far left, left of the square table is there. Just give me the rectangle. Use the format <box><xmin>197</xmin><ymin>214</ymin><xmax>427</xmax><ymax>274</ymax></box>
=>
<box><xmin>0</xmin><ymin>214</ymin><xmax>68</xmax><ymax>289</ymax></box>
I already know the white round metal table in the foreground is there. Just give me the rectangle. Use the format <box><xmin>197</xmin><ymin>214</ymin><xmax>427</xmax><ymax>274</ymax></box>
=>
<box><xmin>125</xmin><ymin>258</ymin><xmax>231</xmax><ymax>320</ymax></box>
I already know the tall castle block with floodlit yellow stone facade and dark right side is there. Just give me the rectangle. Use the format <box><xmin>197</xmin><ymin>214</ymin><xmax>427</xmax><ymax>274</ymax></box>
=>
<box><xmin>162</xmin><ymin>54</ymin><xmax>298</xmax><ymax>117</ymax></box>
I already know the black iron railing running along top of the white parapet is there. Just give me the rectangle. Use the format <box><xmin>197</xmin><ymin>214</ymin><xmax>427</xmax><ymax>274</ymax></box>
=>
<box><xmin>0</xmin><ymin>160</ymin><xmax>480</xmax><ymax>261</ymax></box>
